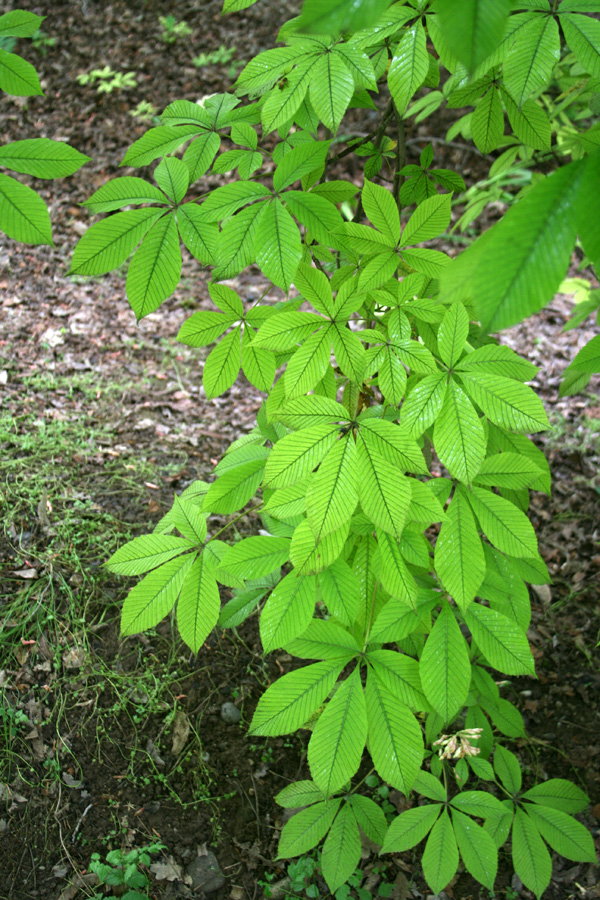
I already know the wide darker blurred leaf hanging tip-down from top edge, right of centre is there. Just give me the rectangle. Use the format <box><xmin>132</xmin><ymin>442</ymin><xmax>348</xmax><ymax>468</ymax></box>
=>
<box><xmin>435</xmin><ymin>0</ymin><xmax>511</xmax><ymax>72</ymax></box>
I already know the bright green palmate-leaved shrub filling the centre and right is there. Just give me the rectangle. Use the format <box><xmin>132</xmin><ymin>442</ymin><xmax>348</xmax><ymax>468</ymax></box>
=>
<box><xmin>0</xmin><ymin>0</ymin><xmax>600</xmax><ymax>897</ymax></box>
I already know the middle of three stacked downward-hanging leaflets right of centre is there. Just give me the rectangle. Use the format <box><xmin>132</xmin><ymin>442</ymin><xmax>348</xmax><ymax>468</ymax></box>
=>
<box><xmin>435</xmin><ymin>491</ymin><xmax>486</xmax><ymax>611</ymax></box>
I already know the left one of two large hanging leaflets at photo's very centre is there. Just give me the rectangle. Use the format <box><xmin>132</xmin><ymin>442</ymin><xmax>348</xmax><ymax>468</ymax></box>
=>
<box><xmin>306</xmin><ymin>434</ymin><xmax>358</xmax><ymax>540</ymax></box>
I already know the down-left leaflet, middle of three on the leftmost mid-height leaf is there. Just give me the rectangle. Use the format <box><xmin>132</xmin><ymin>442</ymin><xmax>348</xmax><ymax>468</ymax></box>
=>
<box><xmin>121</xmin><ymin>553</ymin><xmax>195</xmax><ymax>635</ymax></box>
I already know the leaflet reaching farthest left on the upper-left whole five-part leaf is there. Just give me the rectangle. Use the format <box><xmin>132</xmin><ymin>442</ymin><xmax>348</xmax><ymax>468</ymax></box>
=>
<box><xmin>70</xmin><ymin>209</ymin><xmax>163</xmax><ymax>275</ymax></box>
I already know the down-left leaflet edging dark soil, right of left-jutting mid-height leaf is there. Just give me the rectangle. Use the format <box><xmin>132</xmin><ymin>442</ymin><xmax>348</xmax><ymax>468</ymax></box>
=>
<box><xmin>260</xmin><ymin>572</ymin><xmax>316</xmax><ymax>653</ymax></box>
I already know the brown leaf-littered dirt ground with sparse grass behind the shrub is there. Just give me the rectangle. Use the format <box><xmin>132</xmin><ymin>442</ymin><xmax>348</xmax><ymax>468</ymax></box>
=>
<box><xmin>0</xmin><ymin>0</ymin><xmax>600</xmax><ymax>900</ymax></box>
